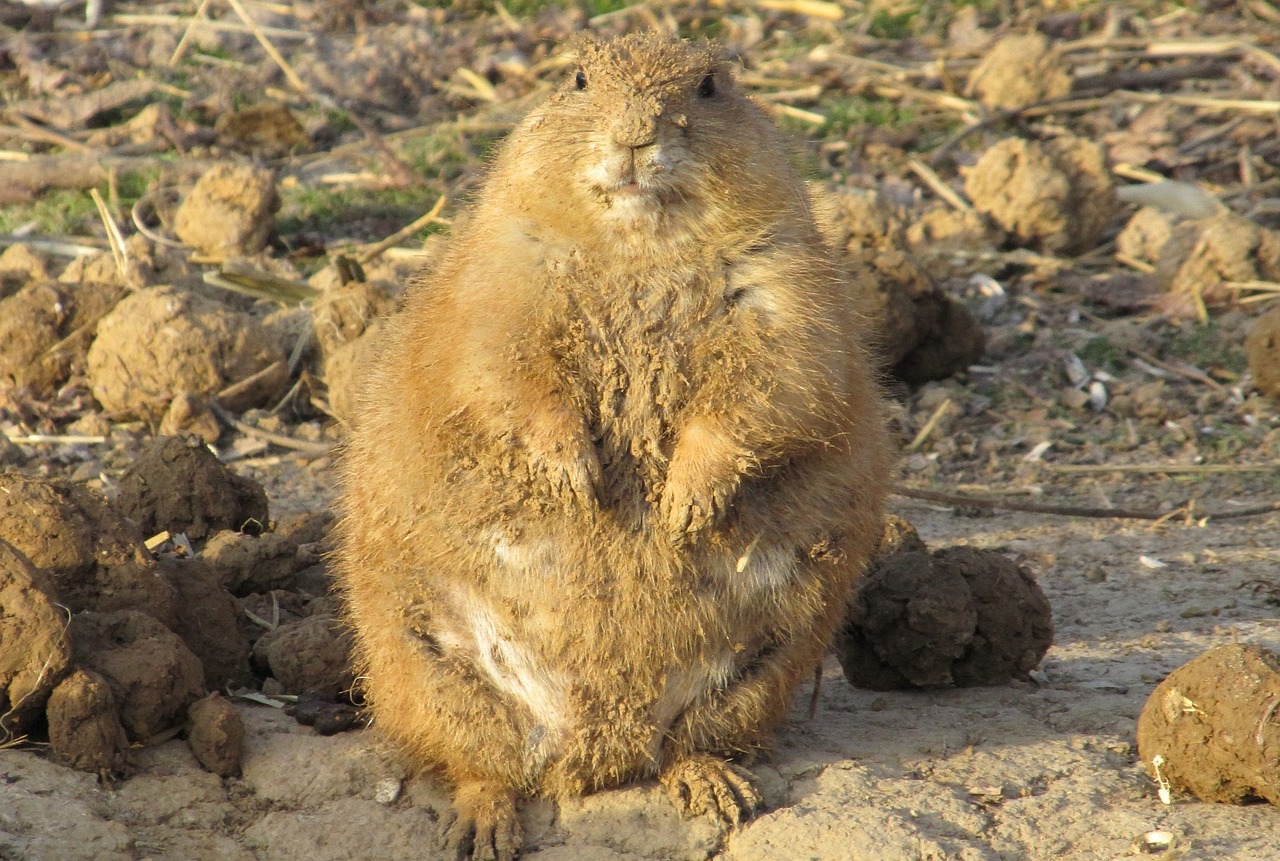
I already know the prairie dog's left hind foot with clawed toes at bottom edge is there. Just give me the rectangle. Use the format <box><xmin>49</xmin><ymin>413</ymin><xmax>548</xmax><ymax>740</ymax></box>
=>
<box><xmin>438</xmin><ymin>780</ymin><xmax>525</xmax><ymax>861</ymax></box>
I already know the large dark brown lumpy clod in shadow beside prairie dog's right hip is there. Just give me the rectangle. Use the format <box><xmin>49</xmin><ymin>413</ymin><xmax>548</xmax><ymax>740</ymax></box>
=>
<box><xmin>836</xmin><ymin>548</ymin><xmax>1053</xmax><ymax>690</ymax></box>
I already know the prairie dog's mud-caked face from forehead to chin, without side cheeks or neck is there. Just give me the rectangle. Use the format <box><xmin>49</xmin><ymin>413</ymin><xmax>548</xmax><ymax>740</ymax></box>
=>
<box><xmin>556</xmin><ymin>35</ymin><xmax>742</xmax><ymax>221</ymax></box>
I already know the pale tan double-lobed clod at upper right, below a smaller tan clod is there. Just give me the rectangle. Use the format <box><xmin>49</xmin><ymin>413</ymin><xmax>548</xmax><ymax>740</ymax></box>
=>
<box><xmin>961</xmin><ymin>134</ymin><xmax>1119</xmax><ymax>255</ymax></box>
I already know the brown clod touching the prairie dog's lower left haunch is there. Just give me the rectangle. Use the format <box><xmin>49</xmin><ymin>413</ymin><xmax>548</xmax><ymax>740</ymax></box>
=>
<box><xmin>253</xmin><ymin>613</ymin><xmax>355</xmax><ymax>697</ymax></box>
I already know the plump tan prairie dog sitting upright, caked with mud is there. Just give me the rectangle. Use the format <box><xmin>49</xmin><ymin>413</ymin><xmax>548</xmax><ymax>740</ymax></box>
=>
<box><xmin>337</xmin><ymin>33</ymin><xmax>890</xmax><ymax>860</ymax></box>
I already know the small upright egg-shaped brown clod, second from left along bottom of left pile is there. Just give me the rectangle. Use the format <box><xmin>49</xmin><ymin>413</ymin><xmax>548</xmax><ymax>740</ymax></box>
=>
<box><xmin>47</xmin><ymin>669</ymin><xmax>129</xmax><ymax>774</ymax></box>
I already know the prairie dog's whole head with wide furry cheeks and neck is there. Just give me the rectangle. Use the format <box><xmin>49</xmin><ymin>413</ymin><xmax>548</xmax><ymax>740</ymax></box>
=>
<box><xmin>497</xmin><ymin>33</ymin><xmax>804</xmax><ymax>238</ymax></box>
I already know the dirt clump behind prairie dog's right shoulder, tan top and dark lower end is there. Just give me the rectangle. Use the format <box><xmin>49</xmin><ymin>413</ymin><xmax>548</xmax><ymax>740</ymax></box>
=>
<box><xmin>815</xmin><ymin>189</ymin><xmax>987</xmax><ymax>384</ymax></box>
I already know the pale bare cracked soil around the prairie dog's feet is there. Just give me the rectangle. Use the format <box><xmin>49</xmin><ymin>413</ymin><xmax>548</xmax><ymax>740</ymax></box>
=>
<box><xmin>0</xmin><ymin>485</ymin><xmax>1280</xmax><ymax>861</ymax></box>
